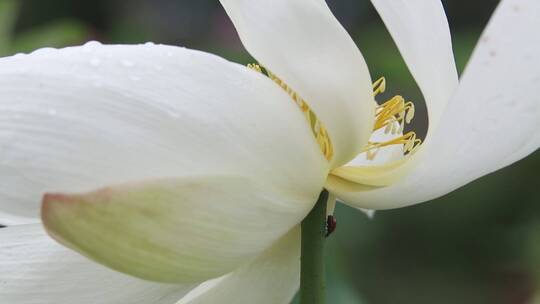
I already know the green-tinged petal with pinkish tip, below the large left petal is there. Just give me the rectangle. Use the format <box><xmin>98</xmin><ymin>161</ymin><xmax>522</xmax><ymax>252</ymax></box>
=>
<box><xmin>42</xmin><ymin>175</ymin><xmax>316</xmax><ymax>283</ymax></box>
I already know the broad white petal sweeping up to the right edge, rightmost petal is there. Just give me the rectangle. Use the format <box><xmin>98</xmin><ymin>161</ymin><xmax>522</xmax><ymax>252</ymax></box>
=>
<box><xmin>327</xmin><ymin>0</ymin><xmax>540</xmax><ymax>209</ymax></box>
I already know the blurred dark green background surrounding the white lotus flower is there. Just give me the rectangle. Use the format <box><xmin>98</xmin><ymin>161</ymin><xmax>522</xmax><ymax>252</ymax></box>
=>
<box><xmin>0</xmin><ymin>0</ymin><xmax>540</xmax><ymax>304</ymax></box>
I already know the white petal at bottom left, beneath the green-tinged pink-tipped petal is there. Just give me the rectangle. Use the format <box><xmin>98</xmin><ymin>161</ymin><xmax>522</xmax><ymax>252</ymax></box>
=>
<box><xmin>0</xmin><ymin>224</ymin><xmax>192</xmax><ymax>304</ymax></box>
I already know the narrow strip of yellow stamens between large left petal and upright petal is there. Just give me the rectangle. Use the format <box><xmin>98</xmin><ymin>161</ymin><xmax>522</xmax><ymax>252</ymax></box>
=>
<box><xmin>248</xmin><ymin>64</ymin><xmax>334</xmax><ymax>161</ymax></box>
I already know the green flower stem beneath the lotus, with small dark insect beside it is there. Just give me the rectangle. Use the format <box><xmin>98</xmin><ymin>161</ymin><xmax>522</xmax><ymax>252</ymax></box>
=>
<box><xmin>300</xmin><ymin>190</ymin><xmax>328</xmax><ymax>304</ymax></box>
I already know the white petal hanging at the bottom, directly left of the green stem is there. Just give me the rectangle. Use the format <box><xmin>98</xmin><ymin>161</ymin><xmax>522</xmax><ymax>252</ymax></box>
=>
<box><xmin>178</xmin><ymin>227</ymin><xmax>300</xmax><ymax>304</ymax></box>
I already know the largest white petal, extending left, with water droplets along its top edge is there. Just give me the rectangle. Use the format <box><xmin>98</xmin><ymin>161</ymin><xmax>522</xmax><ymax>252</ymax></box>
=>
<box><xmin>0</xmin><ymin>43</ymin><xmax>327</xmax><ymax>217</ymax></box>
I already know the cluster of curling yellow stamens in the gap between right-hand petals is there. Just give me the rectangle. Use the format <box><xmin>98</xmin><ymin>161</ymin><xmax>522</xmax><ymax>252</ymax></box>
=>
<box><xmin>362</xmin><ymin>77</ymin><xmax>422</xmax><ymax>160</ymax></box>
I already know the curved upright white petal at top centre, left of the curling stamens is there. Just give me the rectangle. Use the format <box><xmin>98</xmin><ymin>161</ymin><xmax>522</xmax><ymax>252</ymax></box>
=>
<box><xmin>221</xmin><ymin>0</ymin><xmax>374</xmax><ymax>167</ymax></box>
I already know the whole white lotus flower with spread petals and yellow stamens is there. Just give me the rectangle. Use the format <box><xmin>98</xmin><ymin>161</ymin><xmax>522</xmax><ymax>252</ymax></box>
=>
<box><xmin>0</xmin><ymin>0</ymin><xmax>540</xmax><ymax>304</ymax></box>
